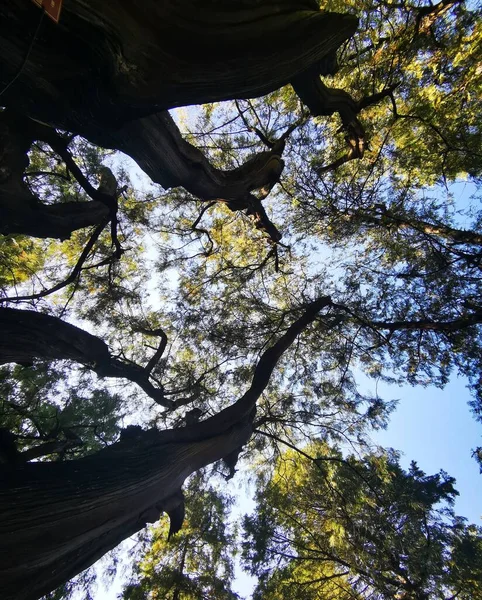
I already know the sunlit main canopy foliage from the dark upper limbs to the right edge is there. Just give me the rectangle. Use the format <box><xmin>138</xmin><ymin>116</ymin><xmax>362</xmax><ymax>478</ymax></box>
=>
<box><xmin>5</xmin><ymin>1</ymin><xmax>481</xmax><ymax>450</ymax></box>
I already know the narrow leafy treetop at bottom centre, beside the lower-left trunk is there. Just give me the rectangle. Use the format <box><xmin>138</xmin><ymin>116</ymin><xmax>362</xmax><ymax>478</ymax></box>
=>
<box><xmin>122</xmin><ymin>473</ymin><xmax>238</xmax><ymax>600</ymax></box>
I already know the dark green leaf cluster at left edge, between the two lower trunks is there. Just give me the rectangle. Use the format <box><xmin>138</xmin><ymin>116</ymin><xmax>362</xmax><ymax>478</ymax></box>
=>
<box><xmin>0</xmin><ymin>362</ymin><xmax>126</xmax><ymax>460</ymax></box>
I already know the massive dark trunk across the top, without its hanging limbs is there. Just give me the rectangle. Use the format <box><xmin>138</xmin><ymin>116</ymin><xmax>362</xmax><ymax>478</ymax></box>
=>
<box><xmin>0</xmin><ymin>0</ymin><xmax>357</xmax><ymax>137</ymax></box>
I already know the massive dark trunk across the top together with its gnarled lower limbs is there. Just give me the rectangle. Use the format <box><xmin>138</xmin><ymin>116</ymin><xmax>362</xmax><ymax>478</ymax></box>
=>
<box><xmin>0</xmin><ymin>0</ymin><xmax>357</xmax><ymax>241</ymax></box>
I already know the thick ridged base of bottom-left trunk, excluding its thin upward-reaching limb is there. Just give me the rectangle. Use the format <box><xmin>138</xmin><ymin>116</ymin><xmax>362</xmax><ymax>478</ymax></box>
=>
<box><xmin>0</xmin><ymin>423</ymin><xmax>251</xmax><ymax>600</ymax></box>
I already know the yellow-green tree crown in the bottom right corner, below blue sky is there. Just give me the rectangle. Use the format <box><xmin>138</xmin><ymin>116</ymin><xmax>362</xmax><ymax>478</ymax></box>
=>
<box><xmin>244</xmin><ymin>442</ymin><xmax>482</xmax><ymax>600</ymax></box>
